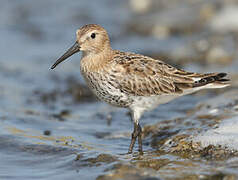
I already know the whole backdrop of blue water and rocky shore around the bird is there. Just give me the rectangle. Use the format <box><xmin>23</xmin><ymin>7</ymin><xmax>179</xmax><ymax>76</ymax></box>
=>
<box><xmin>0</xmin><ymin>0</ymin><xmax>238</xmax><ymax>180</ymax></box>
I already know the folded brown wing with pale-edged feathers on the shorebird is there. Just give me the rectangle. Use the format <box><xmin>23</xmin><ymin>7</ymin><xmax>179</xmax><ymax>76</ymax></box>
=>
<box><xmin>113</xmin><ymin>52</ymin><xmax>218</xmax><ymax>96</ymax></box>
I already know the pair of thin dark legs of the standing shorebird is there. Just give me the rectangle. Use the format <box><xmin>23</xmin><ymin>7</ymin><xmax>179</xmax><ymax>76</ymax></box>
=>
<box><xmin>128</xmin><ymin>123</ymin><xmax>143</xmax><ymax>154</ymax></box>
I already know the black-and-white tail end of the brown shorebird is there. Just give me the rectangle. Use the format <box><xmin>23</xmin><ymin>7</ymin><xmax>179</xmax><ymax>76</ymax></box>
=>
<box><xmin>193</xmin><ymin>73</ymin><xmax>230</xmax><ymax>89</ymax></box>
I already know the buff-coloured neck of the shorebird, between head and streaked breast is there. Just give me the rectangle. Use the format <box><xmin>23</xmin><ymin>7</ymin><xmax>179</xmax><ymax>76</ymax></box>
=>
<box><xmin>80</xmin><ymin>48</ymin><xmax>113</xmax><ymax>72</ymax></box>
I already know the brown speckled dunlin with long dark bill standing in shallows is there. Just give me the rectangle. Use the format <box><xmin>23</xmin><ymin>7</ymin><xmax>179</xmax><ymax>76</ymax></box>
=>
<box><xmin>51</xmin><ymin>24</ymin><xmax>229</xmax><ymax>153</ymax></box>
